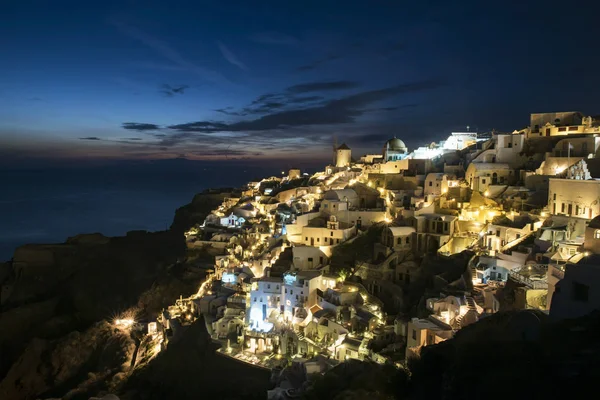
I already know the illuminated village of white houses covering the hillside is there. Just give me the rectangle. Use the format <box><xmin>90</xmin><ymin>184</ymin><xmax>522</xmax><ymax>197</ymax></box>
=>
<box><xmin>151</xmin><ymin>112</ymin><xmax>600</xmax><ymax>398</ymax></box>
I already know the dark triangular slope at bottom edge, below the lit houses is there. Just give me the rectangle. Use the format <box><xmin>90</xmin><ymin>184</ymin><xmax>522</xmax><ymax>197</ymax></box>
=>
<box><xmin>119</xmin><ymin>318</ymin><xmax>271</xmax><ymax>400</ymax></box>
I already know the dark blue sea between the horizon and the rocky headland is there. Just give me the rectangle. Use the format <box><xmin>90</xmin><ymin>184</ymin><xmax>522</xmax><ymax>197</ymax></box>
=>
<box><xmin>0</xmin><ymin>160</ymin><xmax>292</xmax><ymax>261</ymax></box>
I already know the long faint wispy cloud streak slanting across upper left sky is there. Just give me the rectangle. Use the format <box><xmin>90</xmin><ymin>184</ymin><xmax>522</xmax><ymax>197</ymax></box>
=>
<box><xmin>108</xmin><ymin>18</ymin><xmax>229</xmax><ymax>83</ymax></box>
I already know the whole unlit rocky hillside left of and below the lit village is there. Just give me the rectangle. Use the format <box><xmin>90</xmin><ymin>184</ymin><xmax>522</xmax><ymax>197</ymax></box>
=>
<box><xmin>0</xmin><ymin>190</ymin><xmax>269</xmax><ymax>400</ymax></box>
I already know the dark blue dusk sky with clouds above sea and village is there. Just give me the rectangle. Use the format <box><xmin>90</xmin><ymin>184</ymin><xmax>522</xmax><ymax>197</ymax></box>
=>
<box><xmin>0</xmin><ymin>0</ymin><xmax>600</xmax><ymax>162</ymax></box>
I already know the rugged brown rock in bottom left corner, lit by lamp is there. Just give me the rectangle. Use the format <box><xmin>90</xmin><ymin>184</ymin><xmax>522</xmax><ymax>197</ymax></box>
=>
<box><xmin>0</xmin><ymin>321</ymin><xmax>136</xmax><ymax>400</ymax></box>
